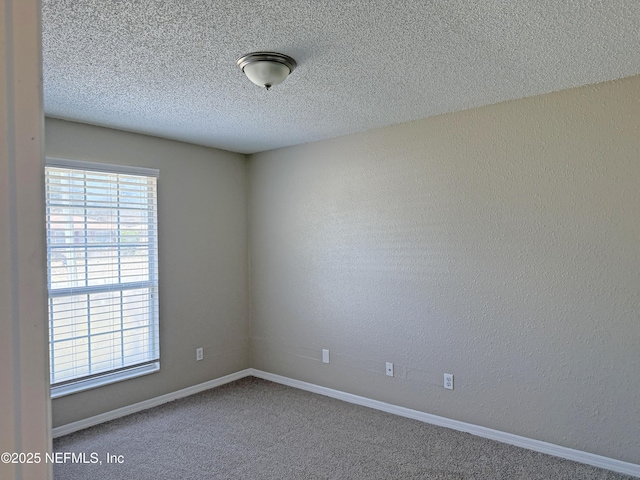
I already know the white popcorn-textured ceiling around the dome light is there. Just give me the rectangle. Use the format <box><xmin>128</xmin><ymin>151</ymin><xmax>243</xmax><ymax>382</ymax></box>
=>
<box><xmin>42</xmin><ymin>0</ymin><xmax>640</xmax><ymax>153</ymax></box>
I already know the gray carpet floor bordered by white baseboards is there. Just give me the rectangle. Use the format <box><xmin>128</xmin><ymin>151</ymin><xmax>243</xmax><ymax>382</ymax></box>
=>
<box><xmin>54</xmin><ymin>377</ymin><xmax>631</xmax><ymax>480</ymax></box>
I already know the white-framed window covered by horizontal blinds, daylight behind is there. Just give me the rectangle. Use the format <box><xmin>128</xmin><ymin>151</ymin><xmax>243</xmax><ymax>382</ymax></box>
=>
<box><xmin>45</xmin><ymin>159</ymin><xmax>160</xmax><ymax>397</ymax></box>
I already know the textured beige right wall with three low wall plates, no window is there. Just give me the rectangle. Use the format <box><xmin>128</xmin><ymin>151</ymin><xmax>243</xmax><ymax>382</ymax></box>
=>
<box><xmin>249</xmin><ymin>77</ymin><xmax>640</xmax><ymax>463</ymax></box>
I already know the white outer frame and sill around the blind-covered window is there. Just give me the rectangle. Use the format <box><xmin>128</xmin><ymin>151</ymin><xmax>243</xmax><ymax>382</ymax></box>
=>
<box><xmin>45</xmin><ymin>157</ymin><xmax>160</xmax><ymax>398</ymax></box>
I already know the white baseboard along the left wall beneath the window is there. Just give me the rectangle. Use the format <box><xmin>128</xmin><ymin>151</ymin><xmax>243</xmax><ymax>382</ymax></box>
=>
<box><xmin>51</xmin><ymin>369</ymin><xmax>251</xmax><ymax>438</ymax></box>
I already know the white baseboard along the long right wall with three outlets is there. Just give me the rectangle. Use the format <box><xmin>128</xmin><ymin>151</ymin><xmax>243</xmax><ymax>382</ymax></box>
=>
<box><xmin>249</xmin><ymin>368</ymin><xmax>640</xmax><ymax>477</ymax></box>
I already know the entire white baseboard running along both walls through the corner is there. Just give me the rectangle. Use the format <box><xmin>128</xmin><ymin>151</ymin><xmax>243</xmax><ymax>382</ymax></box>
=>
<box><xmin>52</xmin><ymin>368</ymin><xmax>640</xmax><ymax>478</ymax></box>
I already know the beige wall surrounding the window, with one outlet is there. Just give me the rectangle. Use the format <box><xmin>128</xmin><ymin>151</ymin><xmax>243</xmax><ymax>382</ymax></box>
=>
<box><xmin>45</xmin><ymin>119</ymin><xmax>249</xmax><ymax>427</ymax></box>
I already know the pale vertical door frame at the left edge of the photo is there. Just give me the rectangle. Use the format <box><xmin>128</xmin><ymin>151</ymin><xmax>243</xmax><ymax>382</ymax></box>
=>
<box><xmin>0</xmin><ymin>0</ymin><xmax>52</xmax><ymax>480</ymax></box>
